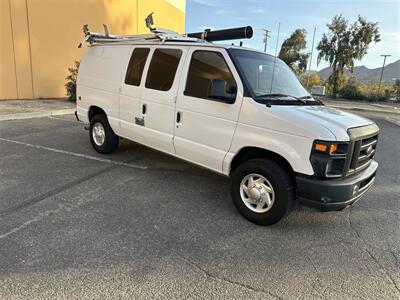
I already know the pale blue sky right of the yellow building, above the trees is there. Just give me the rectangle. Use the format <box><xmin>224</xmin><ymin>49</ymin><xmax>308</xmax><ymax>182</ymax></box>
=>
<box><xmin>186</xmin><ymin>0</ymin><xmax>400</xmax><ymax>70</ymax></box>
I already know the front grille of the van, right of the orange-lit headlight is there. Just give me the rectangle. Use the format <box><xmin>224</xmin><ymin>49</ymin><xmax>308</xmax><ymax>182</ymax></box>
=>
<box><xmin>349</xmin><ymin>134</ymin><xmax>378</xmax><ymax>173</ymax></box>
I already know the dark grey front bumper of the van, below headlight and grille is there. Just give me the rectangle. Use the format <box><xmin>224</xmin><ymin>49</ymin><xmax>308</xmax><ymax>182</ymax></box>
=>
<box><xmin>296</xmin><ymin>161</ymin><xmax>378</xmax><ymax>210</ymax></box>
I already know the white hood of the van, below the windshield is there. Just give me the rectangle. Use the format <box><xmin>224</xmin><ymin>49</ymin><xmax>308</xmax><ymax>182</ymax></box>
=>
<box><xmin>293</xmin><ymin>105</ymin><xmax>374</xmax><ymax>141</ymax></box>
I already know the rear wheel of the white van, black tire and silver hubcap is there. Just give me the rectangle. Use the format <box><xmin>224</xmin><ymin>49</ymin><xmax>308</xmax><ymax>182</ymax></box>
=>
<box><xmin>89</xmin><ymin>114</ymin><xmax>119</xmax><ymax>154</ymax></box>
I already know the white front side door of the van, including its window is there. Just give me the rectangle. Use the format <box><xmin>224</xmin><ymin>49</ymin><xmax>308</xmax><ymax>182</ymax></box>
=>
<box><xmin>174</xmin><ymin>47</ymin><xmax>243</xmax><ymax>172</ymax></box>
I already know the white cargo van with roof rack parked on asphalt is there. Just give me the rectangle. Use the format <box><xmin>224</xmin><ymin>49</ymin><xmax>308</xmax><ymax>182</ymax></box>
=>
<box><xmin>76</xmin><ymin>24</ymin><xmax>379</xmax><ymax>225</ymax></box>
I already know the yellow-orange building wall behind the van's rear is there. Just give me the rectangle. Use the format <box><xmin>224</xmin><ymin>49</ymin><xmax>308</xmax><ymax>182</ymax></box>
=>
<box><xmin>0</xmin><ymin>0</ymin><xmax>185</xmax><ymax>99</ymax></box>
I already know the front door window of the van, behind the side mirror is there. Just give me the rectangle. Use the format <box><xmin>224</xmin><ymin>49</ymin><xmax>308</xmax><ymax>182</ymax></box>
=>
<box><xmin>185</xmin><ymin>50</ymin><xmax>237</xmax><ymax>103</ymax></box>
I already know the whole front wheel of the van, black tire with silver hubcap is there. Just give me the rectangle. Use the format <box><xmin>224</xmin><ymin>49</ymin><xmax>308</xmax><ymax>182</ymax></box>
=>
<box><xmin>231</xmin><ymin>159</ymin><xmax>295</xmax><ymax>225</ymax></box>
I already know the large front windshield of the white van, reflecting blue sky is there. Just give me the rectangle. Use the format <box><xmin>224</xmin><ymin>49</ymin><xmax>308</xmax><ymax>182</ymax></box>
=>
<box><xmin>229</xmin><ymin>49</ymin><xmax>318</xmax><ymax>104</ymax></box>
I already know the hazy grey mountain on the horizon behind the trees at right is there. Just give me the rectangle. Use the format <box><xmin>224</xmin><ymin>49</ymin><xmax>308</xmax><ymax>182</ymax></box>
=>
<box><xmin>318</xmin><ymin>59</ymin><xmax>400</xmax><ymax>83</ymax></box>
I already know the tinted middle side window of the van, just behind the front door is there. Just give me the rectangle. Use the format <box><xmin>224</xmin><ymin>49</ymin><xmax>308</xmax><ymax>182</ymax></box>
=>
<box><xmin>146</xmin><ymin>49</ymin><xmax>182</xmax><ymax>91</ymax></box>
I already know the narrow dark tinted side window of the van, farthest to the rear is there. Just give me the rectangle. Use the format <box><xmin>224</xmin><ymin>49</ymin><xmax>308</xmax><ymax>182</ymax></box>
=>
<box><xmin>125</xmin><ymin>48</ymin><xmax>150</xmax><ymax>86</ymax></box>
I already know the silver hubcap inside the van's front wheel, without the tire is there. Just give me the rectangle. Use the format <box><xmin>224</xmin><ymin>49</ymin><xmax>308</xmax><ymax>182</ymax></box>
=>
<box><xmin>240</xmin><ymin>174</ymin><xmax>275</xmax><ymax>213</ymax></box>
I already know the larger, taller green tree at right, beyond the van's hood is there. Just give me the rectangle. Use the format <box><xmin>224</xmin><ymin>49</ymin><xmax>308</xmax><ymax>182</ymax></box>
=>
<box><xmin>317</xmin><ymin>15</ymin><xmax>380</xmax><ymax>96</ymax></box>
